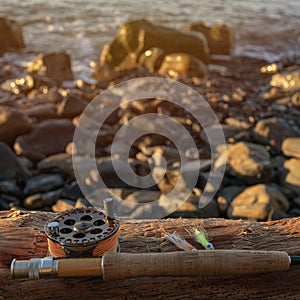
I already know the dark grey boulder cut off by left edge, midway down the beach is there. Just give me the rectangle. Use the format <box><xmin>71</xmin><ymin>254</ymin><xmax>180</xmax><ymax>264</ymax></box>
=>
<box><xmin>0</xmin><ymin>142</ymin><xmax>27</xmax><ymax>181</ymax></box>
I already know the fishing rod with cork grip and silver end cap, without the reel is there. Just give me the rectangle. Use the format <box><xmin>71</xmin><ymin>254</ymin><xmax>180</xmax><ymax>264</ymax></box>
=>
<box><xmin>11</xmin><ymin>250</ymin><xmax>300</xmax><ymax>281</ymax></box>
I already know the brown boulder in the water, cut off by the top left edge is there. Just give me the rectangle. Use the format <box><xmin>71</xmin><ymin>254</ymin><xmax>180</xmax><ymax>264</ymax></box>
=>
<box><xmin>0</xmin><ymin>17</ymin><xmax>25</xmax><ymax>55</ymax></box>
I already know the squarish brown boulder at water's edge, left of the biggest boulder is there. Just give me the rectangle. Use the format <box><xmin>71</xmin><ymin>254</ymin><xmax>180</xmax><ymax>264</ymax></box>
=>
<box><xmin>27</xmin><ymin>52</ymin><xmax>73</xmax><ymax>85</ymax></box>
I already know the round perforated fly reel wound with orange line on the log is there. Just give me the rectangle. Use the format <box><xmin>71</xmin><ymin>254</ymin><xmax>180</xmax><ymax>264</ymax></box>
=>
<box><xmin>44</xmin><ymin>207</ymin><xmax>120</xmax><ymax>257</ymax></box>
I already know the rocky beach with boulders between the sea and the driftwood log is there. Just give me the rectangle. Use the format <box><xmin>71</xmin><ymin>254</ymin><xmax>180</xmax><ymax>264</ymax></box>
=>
<box><xmin>0</xmin><ymin>18</ymin><xmax>300</xmax><ymax>220</ymax></box>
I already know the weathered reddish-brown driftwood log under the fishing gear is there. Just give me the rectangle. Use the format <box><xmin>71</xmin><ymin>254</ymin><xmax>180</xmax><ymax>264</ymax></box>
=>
<box><xmin>0</xmin><ymin>211</ymin><xmax>300</xmax><ymax>299</ymax></box>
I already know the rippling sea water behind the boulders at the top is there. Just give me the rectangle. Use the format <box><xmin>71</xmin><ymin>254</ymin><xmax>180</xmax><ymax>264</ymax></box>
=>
<box><xmin>0</xmin><ymin>0</ymin><xmax>300</xmax><ymax>77</ymax></box>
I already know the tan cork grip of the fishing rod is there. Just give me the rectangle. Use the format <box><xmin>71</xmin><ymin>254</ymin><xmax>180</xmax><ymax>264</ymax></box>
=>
<box><xmin>102</xmin><ymin>250</ymin><xmax>290</xmax><ymax>281</ymax></box>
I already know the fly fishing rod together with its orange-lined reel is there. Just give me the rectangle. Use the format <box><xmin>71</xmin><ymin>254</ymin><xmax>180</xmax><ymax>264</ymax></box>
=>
<box><xmin>11</xmin><ymin>198</ymin><xmax>300</xmax><ymax>281</ymax></box>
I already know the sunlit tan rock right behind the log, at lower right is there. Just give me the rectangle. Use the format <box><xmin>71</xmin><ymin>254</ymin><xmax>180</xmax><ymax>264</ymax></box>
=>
<box><xmin>227</xmin><ymin>184</ymin><xmax>289</xmax><ymax>220</ymax></box>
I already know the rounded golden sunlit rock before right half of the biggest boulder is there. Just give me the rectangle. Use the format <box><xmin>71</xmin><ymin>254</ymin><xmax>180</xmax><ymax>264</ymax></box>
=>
<box><xmin>158</xmin><ymin>53</ymin><xmax>208</xmax><ymax>79</ymax></box>
